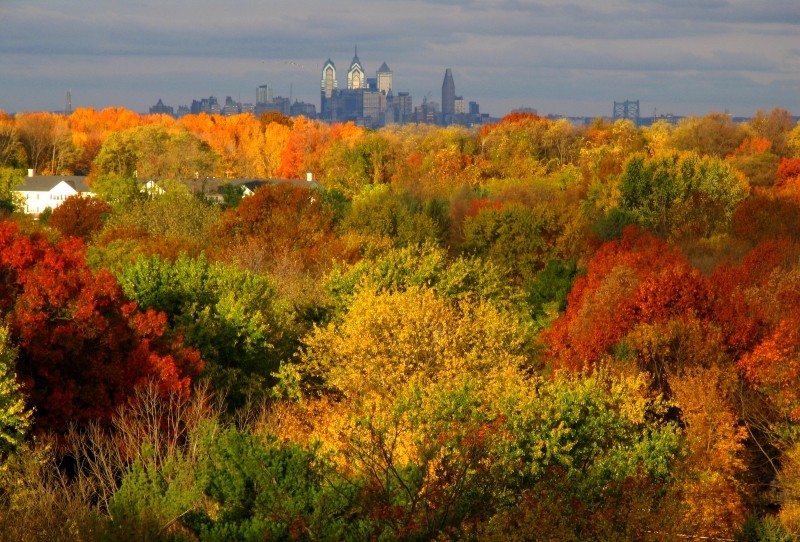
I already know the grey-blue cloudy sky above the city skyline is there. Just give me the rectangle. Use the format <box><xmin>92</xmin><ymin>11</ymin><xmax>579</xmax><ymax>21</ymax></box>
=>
<box><xmin>0</xmin><ymin>0</ymin><xmax>800</xmax><ymax>116</ymax></box>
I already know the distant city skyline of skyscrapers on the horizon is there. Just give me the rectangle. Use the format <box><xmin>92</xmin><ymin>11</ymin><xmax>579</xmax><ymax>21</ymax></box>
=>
<box><xmin>150</xmin><ymin>47</ymin><xmax>493</xmax><ymax>128</ymax></box>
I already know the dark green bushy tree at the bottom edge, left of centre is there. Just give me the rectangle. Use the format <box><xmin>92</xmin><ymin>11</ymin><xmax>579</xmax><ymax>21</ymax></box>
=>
<box><xmin>187</xmin><ymin>429</ymin><xmax>347</xmax><ymax>542</ymax></box>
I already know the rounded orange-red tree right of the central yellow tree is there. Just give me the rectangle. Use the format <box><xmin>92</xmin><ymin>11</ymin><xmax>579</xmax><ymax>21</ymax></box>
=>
<box><xmin>543</xmin><ymin>226</ymin><xmax>711</xmax><ymax>370</ymax></box>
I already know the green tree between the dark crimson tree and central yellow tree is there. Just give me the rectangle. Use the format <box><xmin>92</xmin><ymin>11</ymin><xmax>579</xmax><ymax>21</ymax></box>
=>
<box><xmin>117</xmin><ymin>256</ymin><xmax>294</xmax><ymax>404</ymax></box>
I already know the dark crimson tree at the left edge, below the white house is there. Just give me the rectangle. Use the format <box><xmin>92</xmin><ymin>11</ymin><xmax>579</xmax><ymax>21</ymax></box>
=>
<box><xmin>0</xmin><ymin>222</ymin><xmax>203</xmax><ymax>431</ymax></box>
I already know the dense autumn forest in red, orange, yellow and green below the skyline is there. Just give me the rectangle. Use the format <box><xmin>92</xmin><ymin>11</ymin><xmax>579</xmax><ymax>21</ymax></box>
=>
<box><xmin>0</xmin><ymin>104</ymin><xmax>800</xmax><ymax>542</ymax></box>
